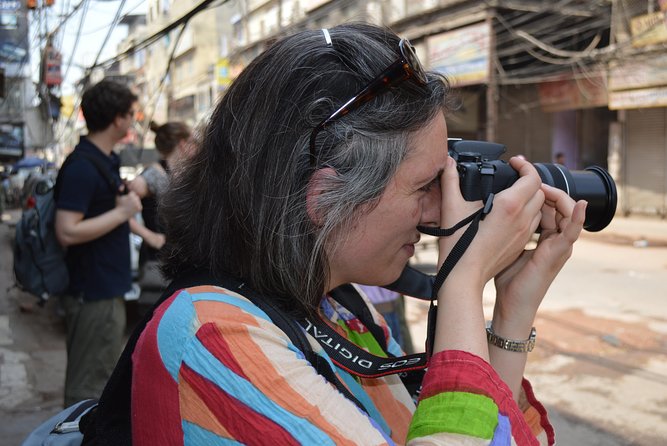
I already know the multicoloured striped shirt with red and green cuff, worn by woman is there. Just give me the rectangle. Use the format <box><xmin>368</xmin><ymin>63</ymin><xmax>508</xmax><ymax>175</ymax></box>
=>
<box><xmin>132</xmin><ymin>286</ymin><xmax>554</xmax><ymax>446</ymax></box>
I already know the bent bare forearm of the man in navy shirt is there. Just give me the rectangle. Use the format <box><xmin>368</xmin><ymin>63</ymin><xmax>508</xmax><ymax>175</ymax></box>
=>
<box><xmin>55</xmin><ymin>192</ymin><xmax>141</xmax><ymax>247</ymax></box>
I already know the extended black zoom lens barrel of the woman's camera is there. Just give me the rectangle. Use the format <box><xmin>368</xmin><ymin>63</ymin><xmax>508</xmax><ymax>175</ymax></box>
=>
<box><xmin>534</xmin><ymin>163</ymin><xmax>617</xmax><ymax>232</ymax></box>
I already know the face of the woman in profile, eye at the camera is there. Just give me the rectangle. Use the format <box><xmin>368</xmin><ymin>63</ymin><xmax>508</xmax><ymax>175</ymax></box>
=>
<box><xmin>328</xmin><ymin>113</ymin><xmax>448</xmax><ymax>289</ymax></box>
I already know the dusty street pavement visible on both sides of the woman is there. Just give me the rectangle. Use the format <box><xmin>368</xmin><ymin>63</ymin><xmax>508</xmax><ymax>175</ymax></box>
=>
<box><xmin>0</xmin><ymin>210</ymin><xmax>667</xmax><ymax>446</ymax></box>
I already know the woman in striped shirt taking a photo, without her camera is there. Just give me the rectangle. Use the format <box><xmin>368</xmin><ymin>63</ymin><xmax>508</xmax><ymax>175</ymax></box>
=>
<box><xmin>118</xmin><ymin>24</ymin><xmax>586</xmax><ymax>445</ymax></box>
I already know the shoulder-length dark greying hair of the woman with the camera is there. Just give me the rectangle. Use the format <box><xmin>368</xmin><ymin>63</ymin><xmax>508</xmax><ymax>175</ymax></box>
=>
<box><xmin>161</xmin><ymin>24</ymin><xmax>456</xmax><ymax>315</ymax></box>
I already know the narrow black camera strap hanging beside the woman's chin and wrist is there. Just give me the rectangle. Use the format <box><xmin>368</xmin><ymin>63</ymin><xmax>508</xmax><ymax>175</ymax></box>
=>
<box><xmin>417</xmin><ymin>193</ymin><xmax>494</xmax><ymax>357</ymax></box>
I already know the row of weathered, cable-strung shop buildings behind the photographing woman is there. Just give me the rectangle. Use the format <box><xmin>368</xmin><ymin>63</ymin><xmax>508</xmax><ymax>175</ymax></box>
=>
<box><xmin>117</xmin><ymin>0</ymin><xmax>667</xmax><ymax>217</ymax></box>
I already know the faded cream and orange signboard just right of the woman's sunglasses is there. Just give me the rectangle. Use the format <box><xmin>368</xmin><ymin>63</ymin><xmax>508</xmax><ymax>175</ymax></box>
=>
<box><xmin>428</xmin><ymin>22</ymin><xmax>491</xmax><ymax>87</ymax></box>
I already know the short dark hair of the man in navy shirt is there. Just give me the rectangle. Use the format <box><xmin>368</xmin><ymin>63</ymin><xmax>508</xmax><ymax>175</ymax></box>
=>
<box><xmin>81</xmin><ymin>80</ymin><xmax>138</xmax><ymax>132</ymax></box>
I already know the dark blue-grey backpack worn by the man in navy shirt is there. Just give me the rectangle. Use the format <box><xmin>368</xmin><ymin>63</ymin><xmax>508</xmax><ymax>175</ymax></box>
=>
<box><xmin>12</xmin><ymin>150</ymin><xmax>120</xmax><ymax>305</ymax></box>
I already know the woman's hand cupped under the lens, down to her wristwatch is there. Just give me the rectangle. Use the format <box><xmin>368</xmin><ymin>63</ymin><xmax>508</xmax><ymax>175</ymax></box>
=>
<box><xmin>493</xmin><ymin>184</ymin><xmax>587</xmax><ymax>328</ymax></box>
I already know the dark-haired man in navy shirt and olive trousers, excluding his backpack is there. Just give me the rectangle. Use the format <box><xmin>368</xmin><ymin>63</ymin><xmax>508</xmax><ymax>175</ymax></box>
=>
<box><xmin>55</xmin><ymin>80</ymin><xmax>141</xmax><ymax>407</ymax></box>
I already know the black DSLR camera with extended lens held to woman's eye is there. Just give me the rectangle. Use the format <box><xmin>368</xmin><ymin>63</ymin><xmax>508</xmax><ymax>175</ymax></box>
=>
<box><xmin>448</xmin><ymin>138</ymin><xmax>617</xmax><ymax>232</ymax></box>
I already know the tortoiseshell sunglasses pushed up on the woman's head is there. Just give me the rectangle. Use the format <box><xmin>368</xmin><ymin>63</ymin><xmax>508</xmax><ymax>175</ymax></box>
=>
<box><xmin>310</xmin><ymin>39</ymin><xmax>427</xmax><ymax>167</ymax></box>
